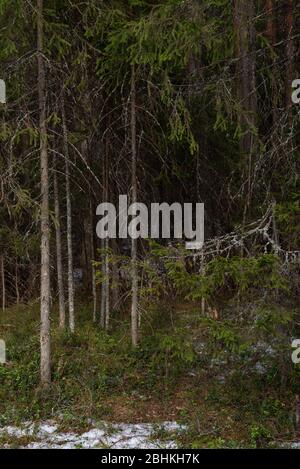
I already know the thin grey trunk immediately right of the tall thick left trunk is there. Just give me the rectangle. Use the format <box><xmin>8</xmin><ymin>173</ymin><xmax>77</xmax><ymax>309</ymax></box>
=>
<box><xmin>54</xmin><ymin>155</ymin><xmax>66</xmax><ymax>329</ymax></box>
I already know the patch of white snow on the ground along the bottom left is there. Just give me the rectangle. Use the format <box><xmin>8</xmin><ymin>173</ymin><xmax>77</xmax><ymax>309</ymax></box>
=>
<box><xmin>0</xmin><ymin>421</ymin><xmax>184</xmax><ymax>449</ymax></box>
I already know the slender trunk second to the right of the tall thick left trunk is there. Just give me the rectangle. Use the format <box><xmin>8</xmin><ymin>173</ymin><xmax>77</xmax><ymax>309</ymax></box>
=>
<box><xmin>62</xmin><ymin>98</ymin><xmax>75</xmax><ymax>332</ymax></box>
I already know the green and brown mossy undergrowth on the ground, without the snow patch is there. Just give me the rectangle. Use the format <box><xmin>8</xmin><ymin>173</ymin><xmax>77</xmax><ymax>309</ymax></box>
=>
<box><xmin>0</xmin><ymin>292</ymin><xmax>299</xmax><ymax>448</ymax></box>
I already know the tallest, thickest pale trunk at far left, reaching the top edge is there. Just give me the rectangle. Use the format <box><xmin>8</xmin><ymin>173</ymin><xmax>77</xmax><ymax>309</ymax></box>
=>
<box><xmin>37</xmin><ymin>0</ymin><xmax>51</xmax><ymax>386</ymax></box>
